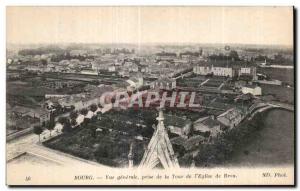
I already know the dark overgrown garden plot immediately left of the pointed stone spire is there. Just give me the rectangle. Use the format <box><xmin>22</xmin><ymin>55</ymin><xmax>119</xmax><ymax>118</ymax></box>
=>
<box><xmin>44</xmin><ymin>126</ymin><xmax>144</xmax><ymax>167</ymax></box>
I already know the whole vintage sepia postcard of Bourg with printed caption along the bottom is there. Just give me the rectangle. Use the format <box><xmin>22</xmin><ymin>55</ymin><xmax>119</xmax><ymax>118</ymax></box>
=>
<box><xmin>6</xmin><ymin>6</ymin><xmax>296</xmax><ymax>186</ymax></box>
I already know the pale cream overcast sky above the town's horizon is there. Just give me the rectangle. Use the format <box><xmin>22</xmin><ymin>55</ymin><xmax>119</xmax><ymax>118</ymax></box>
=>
<box><xmin>6</xmin><ymin>7</ymin><xmax>293</xmax><ymax>45</ymax></box>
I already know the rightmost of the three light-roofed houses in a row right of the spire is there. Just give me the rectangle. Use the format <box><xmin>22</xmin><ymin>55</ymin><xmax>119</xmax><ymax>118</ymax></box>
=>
<box><xmin>217</xmin><ymin>108</ymin><xmax>244</xmax><ymax>129</ymax></box>
